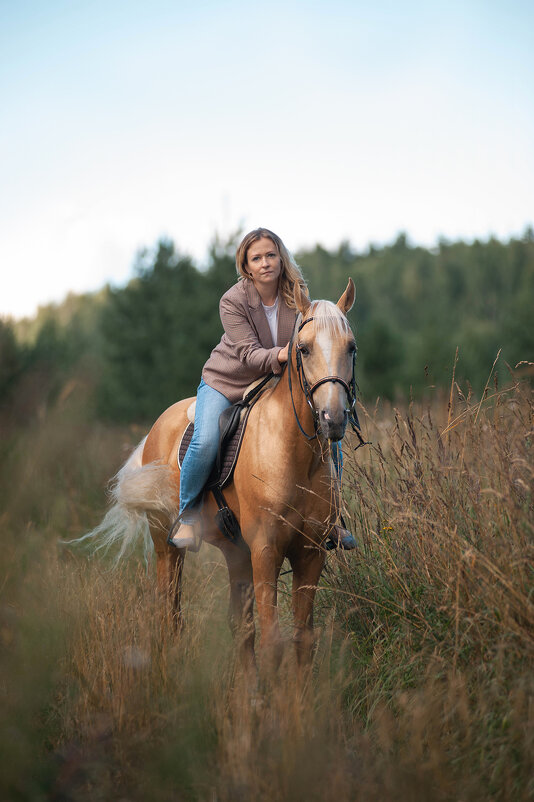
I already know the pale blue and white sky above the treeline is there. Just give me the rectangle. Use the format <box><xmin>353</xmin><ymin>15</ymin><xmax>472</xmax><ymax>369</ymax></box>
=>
<box><xmin>0</xmin><ymin>0</ymin><xmax>534</xmax><ymax>318</ymax></box>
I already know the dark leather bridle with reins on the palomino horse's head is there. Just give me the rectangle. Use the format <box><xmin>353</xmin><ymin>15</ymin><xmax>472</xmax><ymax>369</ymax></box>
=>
<box><xmin>287</xmin><ymin>316</ymin><xmax>367</xmax><ymax>448</ymax></box>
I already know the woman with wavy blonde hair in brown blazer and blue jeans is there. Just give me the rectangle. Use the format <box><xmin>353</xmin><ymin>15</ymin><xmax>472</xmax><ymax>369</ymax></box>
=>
<box><xmin>168</xmin><ymin>228</ymin><xmax>356</xmax><ymax>549</ymax></box>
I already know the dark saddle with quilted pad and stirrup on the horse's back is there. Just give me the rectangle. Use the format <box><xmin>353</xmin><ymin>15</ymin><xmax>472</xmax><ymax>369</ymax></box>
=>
<box><xmin>178</xmin><ymin>373</ymin><xmax>274</xmax><ymax>548</ymax></box>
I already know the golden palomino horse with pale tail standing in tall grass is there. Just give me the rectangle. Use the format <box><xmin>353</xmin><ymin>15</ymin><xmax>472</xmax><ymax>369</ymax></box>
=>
<box><xmin>92</xmin><ymin>279</ymin><xmax>356</xmax><ymax>662</ymax></box>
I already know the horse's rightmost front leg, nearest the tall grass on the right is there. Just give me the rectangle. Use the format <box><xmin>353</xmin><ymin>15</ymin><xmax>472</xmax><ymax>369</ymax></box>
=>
<box><xmin>288</xmin><ymin>546</ymin><xmax>325</xmax><ymax>665</ymax></box>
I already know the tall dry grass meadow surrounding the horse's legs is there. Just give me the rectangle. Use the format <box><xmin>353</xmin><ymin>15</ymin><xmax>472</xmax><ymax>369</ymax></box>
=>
<box><xmin>0</xmin><ymin>374</ymin><xmax>534</xmax><ymax>802</ymax></box>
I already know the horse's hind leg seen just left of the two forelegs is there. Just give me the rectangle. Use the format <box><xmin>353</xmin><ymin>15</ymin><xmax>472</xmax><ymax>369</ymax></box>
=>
<box><xmin>220</xmin><ymin>541</ymin><xmax>256</xmax><ymax>670</ymax></box>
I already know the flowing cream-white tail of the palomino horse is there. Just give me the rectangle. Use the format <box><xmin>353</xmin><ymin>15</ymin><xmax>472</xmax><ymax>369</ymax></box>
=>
<box><xmin>71</xmin><ymin>437</ymin><xmax>178</xmax><ymax>562</ymax></box>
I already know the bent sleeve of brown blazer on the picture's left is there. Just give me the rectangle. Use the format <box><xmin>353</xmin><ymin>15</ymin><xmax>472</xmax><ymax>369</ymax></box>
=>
<box><xmin>219</xmin><ymin>296</ymin><xmax>282</xmax><ymax>376</ymax></box>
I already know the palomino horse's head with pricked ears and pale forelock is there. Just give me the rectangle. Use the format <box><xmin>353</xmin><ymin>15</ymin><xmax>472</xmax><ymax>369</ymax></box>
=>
<box><xmin>294</xmin><ymin>278</ymin><xmax>356</xmax><ymax>440</ymax></box>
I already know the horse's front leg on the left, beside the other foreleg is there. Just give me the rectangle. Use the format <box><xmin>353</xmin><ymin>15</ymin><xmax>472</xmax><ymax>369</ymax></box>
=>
<box><xmin>251</xmin><ymin>542</ymin><xmax>284</xmax><ymax>665</ymax></box>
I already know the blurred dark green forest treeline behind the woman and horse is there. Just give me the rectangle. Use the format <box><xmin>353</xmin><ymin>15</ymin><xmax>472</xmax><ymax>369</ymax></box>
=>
<box><xmin>0</xmin><ymin>228</ymin><xmax>534</xmax><ymax>422</ymax></box>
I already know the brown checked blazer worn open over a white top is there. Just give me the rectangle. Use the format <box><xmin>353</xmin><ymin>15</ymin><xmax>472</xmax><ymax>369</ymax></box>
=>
<box><xmin>202</xmin><ymin>279</ymin><xmax>297</xmax><ymax>402</ymax></box>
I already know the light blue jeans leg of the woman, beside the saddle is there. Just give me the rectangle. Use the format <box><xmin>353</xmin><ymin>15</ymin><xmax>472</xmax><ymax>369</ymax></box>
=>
<box><xmin>180</xmin><ymin>379</ymin><xmax>231</xmax><ymax>524</ymax></box>
